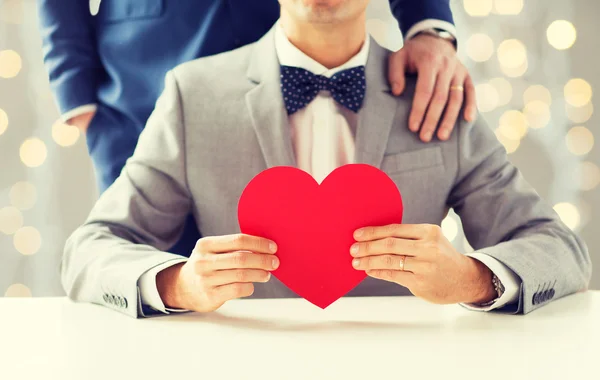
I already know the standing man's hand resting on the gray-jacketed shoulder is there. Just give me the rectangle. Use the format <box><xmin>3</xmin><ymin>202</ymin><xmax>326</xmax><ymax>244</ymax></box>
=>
<box><xmin>389</xmin><ymin>35</ymin><xmax>477</xmax><ymax>142</ymax></box>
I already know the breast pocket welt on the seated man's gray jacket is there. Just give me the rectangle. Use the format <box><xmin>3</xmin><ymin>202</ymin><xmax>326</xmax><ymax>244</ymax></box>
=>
<box><xmin>381</xmin><ymin>146</ymin><xmax>444</xmax><ymax>174</ymax></box>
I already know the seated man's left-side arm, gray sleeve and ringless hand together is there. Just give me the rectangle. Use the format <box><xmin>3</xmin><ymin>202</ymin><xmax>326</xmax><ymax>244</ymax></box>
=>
<box><xmin>61</xmin><ymin>72</ymin><xmax>279</xmax><ymax>317</ymax></box>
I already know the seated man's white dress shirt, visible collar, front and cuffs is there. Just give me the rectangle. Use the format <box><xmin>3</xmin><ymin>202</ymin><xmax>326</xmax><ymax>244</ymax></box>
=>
<box><xmin>138</xmin><ymin>22</ymin><xmax>520</xmax><ymax>313</ymax></box>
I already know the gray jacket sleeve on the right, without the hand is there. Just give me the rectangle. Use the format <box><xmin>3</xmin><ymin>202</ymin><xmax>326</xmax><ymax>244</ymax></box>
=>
<box><xmin>448</xmin><ymin>113</ymin><xmax>591</xmax><ymax>313</ymax></box>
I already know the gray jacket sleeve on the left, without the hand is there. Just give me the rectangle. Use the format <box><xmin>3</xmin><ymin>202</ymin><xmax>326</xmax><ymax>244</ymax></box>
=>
<box><xmin>61</xmin><ymin>72</ymin><xmax>192</xmax><ymax>317</ymax></box>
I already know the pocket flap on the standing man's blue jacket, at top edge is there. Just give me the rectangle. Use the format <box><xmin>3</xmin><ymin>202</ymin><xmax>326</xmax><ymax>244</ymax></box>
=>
<box><xmin>98</xmin><ymin>0</ymin><xmax>165</xmax><ymax>23</ymax></box>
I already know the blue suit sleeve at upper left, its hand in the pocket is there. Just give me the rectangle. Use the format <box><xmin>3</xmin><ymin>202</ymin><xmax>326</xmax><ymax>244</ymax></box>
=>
<box><xmin>38</xmin><ymin>0</ymin><xmax>102</xmax><ymax>113</ymax></box>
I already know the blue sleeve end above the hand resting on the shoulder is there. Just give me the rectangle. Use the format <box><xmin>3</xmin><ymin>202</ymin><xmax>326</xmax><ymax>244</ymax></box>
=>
<box><xmin>390</xmin><ymin>0</ymin><xmax>454</xmax><ymax>36</ymax></box>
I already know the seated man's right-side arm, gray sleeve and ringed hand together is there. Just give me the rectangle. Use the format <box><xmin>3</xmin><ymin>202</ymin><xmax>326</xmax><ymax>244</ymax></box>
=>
<box><xmin>350</xmin><ymin>113</ymin><xmax>591</xmax><ymax>313</ymax></box>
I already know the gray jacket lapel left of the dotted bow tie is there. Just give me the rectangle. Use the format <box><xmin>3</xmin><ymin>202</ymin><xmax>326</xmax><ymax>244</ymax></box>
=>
<box><xmin>246</xmin><ymin>29</ymin><xmax>296</xmax><ymax>168</ymax></box>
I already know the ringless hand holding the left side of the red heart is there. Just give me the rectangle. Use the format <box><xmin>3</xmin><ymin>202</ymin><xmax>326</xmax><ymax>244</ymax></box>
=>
<box><xmin>156</xmin><ymin>234</ymin><xmax>279</xmax><ymax>312</ymax></box>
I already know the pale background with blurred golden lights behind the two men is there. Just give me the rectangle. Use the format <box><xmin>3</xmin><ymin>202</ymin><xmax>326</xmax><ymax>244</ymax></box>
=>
<box><xmin>0</xmin><ymin>0</ymin><xmax>600</xmax><ymax>297</ymax></box>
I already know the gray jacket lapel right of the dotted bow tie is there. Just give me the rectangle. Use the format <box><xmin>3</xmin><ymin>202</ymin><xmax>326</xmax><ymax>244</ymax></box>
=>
<box><xmin>355</xmin><ymin>39</ymin><xmax>398</xmax><ymax>168</ymax></box>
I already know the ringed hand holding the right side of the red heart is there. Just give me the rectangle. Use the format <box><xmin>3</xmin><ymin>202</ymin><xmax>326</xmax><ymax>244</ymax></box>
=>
<box><xmin>350</xmin><ymin>224</ymin><xmax>496</xmax><ymax>304</ymax></box>
